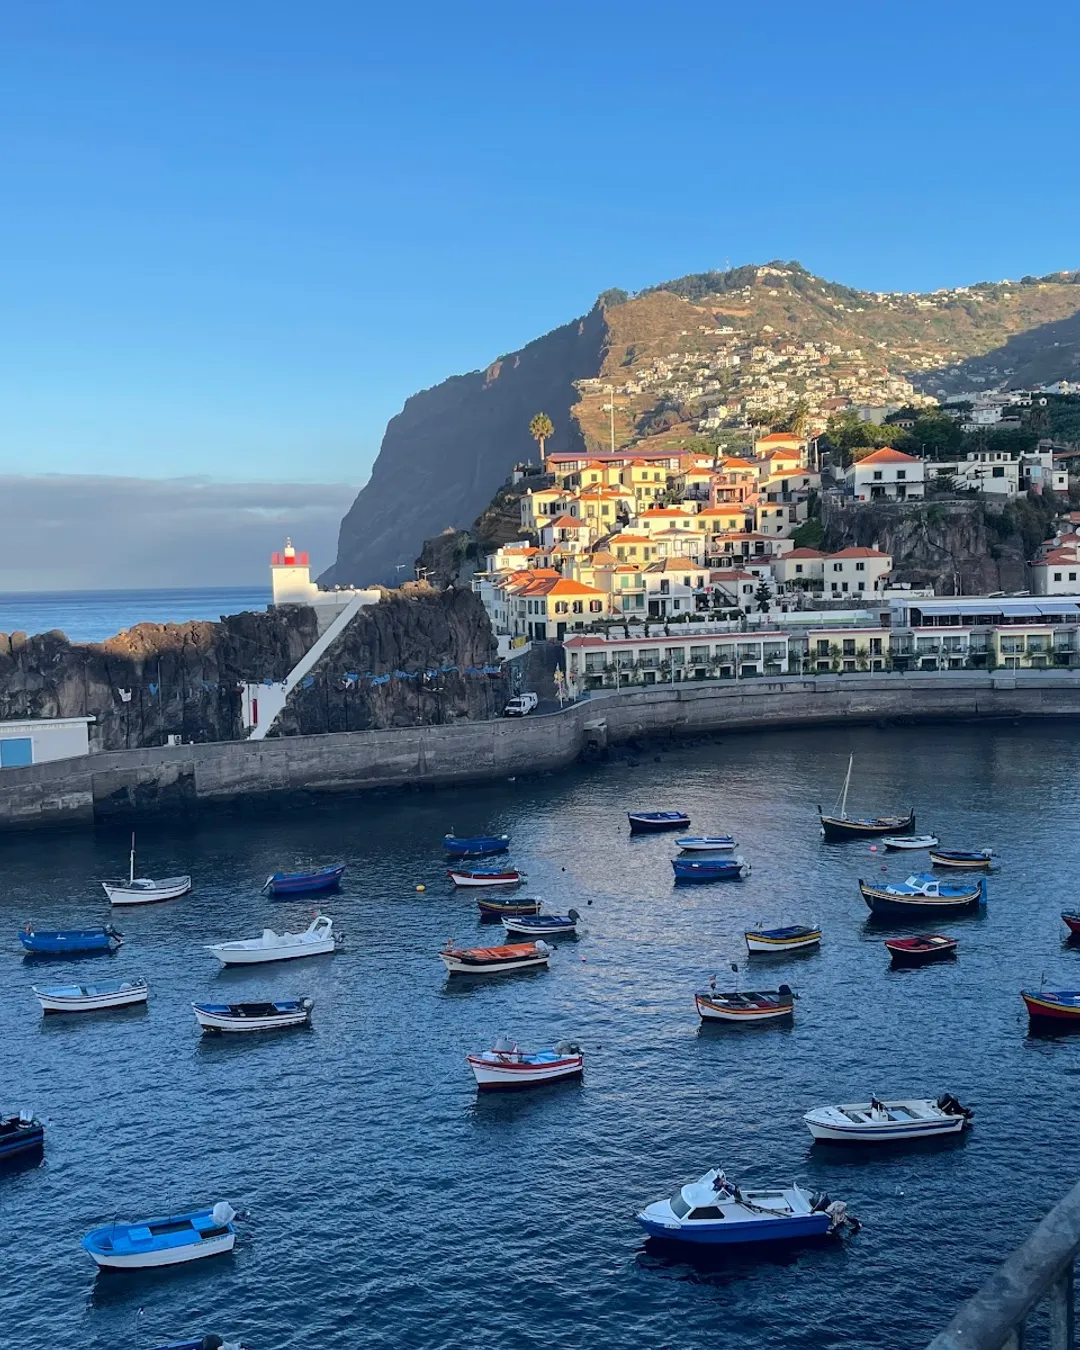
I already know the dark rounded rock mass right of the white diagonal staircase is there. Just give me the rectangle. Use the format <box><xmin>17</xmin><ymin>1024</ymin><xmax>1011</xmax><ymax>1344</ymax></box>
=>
<box><xmin>270</xmin><ymin>585</ymin><xmax>505</xmax><ymax>736</ymax></box>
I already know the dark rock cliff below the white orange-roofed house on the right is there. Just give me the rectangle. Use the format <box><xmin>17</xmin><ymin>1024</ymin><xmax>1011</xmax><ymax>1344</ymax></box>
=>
<box><xmin>822</xmin><ymin>500</ymin><xmax>1053</xmax><ymax>595</ymax></box>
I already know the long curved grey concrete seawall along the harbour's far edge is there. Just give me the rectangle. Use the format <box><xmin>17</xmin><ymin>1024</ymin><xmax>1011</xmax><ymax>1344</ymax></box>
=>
<box><xmin>0</xmin><ymin>671</ymin><xmax>1080</xmax><ymax>829</ymax></box>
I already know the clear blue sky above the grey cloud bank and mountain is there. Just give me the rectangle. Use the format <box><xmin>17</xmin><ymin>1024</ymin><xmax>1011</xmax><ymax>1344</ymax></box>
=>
<box><xmin>0</xmin><ymin>0</ymin><xmax>1080</xmax><ymax>485</ymax></box>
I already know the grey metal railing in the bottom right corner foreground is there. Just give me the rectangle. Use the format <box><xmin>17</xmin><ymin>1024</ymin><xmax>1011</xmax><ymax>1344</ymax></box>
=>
<box><xmin>927</xmin><ymin>1181</ymin><xmax>1080</xmax><ymax>1350</ymax></box>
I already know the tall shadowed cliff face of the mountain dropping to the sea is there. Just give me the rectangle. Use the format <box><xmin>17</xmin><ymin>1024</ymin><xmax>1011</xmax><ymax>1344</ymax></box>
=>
<box><xmin>324</xmin><ymin>308</ymin><xmax>606</xmax><ymax>585</ymax></box>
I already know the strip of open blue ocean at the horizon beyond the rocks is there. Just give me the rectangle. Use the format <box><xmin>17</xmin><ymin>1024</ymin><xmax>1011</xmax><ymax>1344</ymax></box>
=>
<box><xmin>0</xmin><ymin>586</ymin><xmax>270</xmax><ymax>643</ymax></box>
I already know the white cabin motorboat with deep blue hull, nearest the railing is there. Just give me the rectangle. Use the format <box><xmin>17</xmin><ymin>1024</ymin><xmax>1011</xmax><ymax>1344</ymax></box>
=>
<box><xmin>635</xmin><ymin>1168</ymin><xmax>859</xmax><ymax>1246</ymax></box>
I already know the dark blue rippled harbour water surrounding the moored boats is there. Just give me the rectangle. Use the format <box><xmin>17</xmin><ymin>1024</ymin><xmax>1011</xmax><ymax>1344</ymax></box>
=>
<box><xmin>0</xmin><ymin>722</ymin><xmax>1080</xmax><ymax>1350</ymax></box>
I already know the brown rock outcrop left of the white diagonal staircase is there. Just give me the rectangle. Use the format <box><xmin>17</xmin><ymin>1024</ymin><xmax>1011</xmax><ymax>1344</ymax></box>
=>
<box><xmin>0</xmin><ymin>606</ymin><xmax>317</xmax><ymax>749</ymax></box>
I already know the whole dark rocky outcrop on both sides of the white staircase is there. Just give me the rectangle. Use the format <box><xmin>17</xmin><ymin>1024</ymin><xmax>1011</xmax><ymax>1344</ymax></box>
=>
<box><xmin>0</xmin><ymin>586</ymin><xmax>501</xmax><ymax>751</ymax></box>
